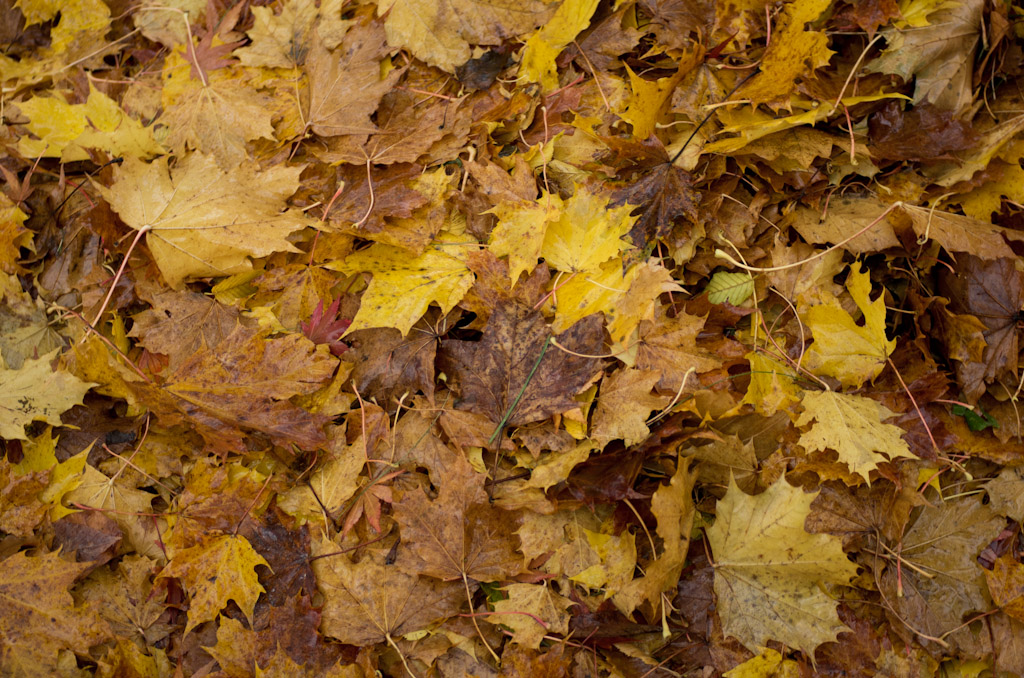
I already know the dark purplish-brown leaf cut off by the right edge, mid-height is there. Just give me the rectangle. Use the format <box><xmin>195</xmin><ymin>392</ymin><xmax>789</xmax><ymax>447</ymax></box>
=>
<box><xmin>939</xmin><ymin>254</ymin><xmax>1024</xmax><ymax>405</ymax></box>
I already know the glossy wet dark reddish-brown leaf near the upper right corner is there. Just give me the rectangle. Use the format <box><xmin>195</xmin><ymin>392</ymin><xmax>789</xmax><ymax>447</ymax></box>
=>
<box><xmin>867</xmin><ymin>101</ymin><xmax>978</xmax><ymax>161</ymax></box>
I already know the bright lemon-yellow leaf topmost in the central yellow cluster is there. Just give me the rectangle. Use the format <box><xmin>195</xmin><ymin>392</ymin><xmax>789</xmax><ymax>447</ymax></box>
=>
<box><xmin>541</xmin><ymin>186</ymin><xmax>636</xmax><ymax>272</ymax></box>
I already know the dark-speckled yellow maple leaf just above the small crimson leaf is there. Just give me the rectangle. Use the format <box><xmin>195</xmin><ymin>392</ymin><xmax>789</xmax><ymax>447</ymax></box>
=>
<box><xmin>328</xmin><ymin>238</ymin><xmax>474</xmax><ymax>336</ymax></box>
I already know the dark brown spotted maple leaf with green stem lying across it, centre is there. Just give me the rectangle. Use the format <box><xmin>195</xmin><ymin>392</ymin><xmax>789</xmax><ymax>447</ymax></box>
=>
<box><xmin>440</xmin><ymin>302</ymin><xmax>603</xmax><ymax>426</ymax></box>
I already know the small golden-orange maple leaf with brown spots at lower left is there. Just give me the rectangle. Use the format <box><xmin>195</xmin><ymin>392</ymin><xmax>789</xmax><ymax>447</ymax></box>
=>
<box><xmin>159</xmin><ymin>535</ymin><xmax>270</xmax><ymax>634</ymax></box>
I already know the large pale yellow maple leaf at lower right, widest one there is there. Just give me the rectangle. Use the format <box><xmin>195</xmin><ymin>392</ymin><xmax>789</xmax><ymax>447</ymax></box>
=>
<box><xmin>707</xmin><ymin>478</ymin><xmax>857</xmax><ymax>656</ymax></box>
